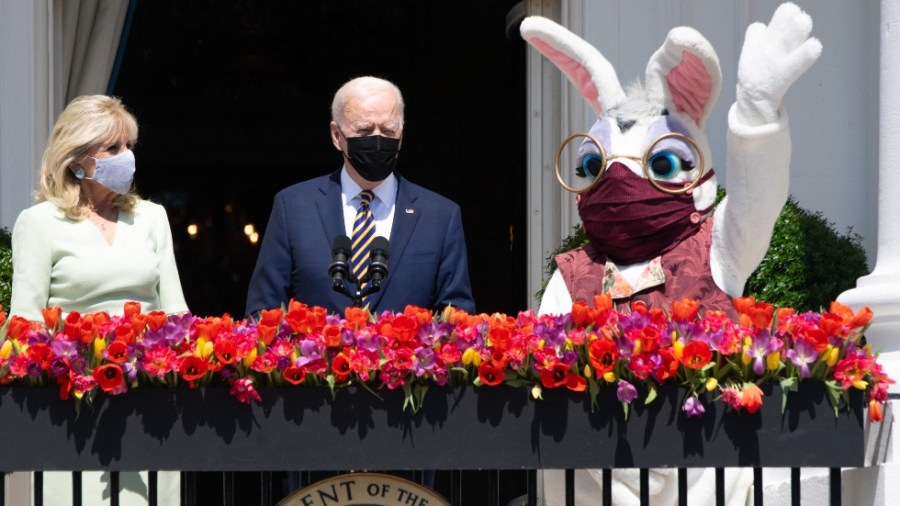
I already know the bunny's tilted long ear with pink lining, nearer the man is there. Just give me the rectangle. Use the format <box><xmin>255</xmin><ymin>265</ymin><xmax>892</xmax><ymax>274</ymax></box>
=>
<box><xmin>519</xmin><ymin>16</ymin><xmax>625</xmax><ymax>116</ymax></box>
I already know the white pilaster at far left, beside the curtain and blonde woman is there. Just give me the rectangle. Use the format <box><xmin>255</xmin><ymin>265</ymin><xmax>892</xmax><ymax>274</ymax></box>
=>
<box><xmin>0</xmin><ymin>0</ymin><xmax>56</xmax><ymax>229</ymax></box>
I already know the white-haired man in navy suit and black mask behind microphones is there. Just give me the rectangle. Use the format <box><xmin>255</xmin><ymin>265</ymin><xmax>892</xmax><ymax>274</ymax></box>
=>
<box><xmin>247</xmin><ymin>77</ymin><xmax>475</xmax><ymax>316</ymax></box>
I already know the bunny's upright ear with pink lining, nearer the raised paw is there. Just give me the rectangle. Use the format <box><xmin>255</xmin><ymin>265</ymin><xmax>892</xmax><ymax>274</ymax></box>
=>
<box><xmin>646</xmin><ymin>26</ymin><xmax>722</xmax><ymax>128</ymax></box>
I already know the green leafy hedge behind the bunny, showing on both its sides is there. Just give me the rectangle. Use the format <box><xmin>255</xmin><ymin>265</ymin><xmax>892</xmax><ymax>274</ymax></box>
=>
<box><xmin>536</xmin><ymin>198</ymin><xmax>869</xmax><ymax>311</ymax></box>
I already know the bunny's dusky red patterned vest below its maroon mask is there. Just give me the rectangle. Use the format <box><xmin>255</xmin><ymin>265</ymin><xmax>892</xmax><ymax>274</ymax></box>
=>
<box><xmin>556</xmin><ymin>218</ymin><xmax>736</xmax><ymax>318</ymax></box>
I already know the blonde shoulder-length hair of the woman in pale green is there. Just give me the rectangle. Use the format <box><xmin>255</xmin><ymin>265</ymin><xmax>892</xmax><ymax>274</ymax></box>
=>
<box><xmin>35</xmin><ymin>95</ymin><xmax>140</xmax><ymax>220</ymax></box>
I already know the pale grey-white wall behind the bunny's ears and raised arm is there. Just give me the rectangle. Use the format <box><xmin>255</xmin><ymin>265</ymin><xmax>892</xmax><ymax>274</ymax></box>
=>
<box><xmin>557</xmin><ymin>0</ymin><xmax>880</xmax><ymax>268</ymax></box>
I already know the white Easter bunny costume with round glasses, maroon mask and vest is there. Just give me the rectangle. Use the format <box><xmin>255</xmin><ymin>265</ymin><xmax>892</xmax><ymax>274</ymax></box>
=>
<box><xmin>520</xmin><ymin>3</ymin><xmax>822</xmax><ymax>505</ymax></box>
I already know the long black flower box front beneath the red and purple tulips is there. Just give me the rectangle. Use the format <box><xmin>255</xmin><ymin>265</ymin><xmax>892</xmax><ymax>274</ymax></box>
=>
<box><xmin>0</xmin><ymin>382</ymin><xmax>866</xmax><ymax>471</ymax></box>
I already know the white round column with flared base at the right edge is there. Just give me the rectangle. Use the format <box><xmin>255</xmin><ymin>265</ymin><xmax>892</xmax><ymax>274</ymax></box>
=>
<box><xmin>838</xmin><ymin>0</ymin><xmax>900</xmax><ymax>393</ymax></box>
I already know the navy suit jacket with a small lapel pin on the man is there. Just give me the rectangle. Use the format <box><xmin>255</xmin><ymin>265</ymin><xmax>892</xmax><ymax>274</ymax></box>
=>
<box><xmin>247</xmin><ymin>171</ymin><xmax>475</xmax><ymax>315</ymax></box>
